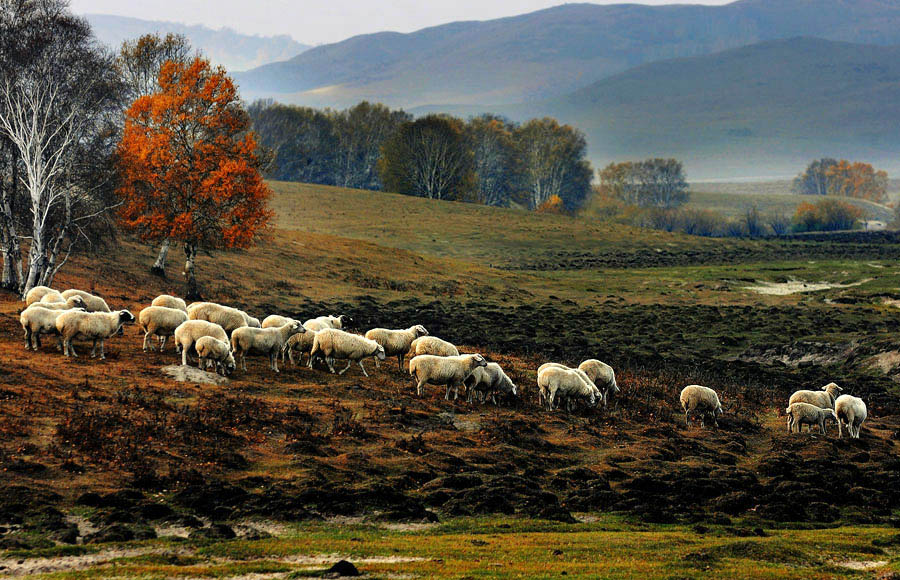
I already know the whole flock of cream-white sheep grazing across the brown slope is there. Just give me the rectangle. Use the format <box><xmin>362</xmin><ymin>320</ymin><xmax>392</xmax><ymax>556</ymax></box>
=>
<box><xmin>20</xmin><ymin>286</ymin><xmax>867</xmax><ymax>438</ymax></box>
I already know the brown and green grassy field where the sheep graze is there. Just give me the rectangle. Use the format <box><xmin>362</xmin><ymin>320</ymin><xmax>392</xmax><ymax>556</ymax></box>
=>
<box><xmin>0</xmin><ymin>184</ymin><xmax>900</xmax><ymax>578</ymax></box>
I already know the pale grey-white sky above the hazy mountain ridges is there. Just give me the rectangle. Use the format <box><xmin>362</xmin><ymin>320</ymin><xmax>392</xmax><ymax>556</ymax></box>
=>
<box><xmin>71</xmin><ymin>0</ymin><xmax>733</xmax><ymax>44</ymax></box>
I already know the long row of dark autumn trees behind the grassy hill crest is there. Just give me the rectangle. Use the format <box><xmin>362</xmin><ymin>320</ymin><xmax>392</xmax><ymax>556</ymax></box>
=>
<box><xmin>249</xmin><ymin>101</ymin><xmax>593</xmax><ymax>211</ymax></box>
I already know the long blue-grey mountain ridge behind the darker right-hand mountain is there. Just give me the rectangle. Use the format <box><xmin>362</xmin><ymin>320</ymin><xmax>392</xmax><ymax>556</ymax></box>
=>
<box><xmin>238</xmin><ymin>0</ymin><xmax>900</xmax><ymax>107</ymax></box>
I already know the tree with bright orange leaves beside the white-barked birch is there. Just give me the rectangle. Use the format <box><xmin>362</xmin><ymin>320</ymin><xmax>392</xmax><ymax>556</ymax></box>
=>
<box><xmin>118</xmin><ymin>58</ymin><xmax>272</xmax><ymax>299</ymax></box>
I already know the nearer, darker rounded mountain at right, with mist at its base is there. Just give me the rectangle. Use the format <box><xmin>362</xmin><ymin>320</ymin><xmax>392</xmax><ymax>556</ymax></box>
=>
<box><xmin>502</xmin><ymin>38</ymin><xmax>900</xmax><ymax>179</ymax></box>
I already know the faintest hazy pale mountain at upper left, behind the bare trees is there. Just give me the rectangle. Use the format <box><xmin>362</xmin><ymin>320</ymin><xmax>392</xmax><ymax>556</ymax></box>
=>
<box><xmin>85</xmin><ymin>14</ymin><xmax>310</xmax><ymax>72</ymax></box>
